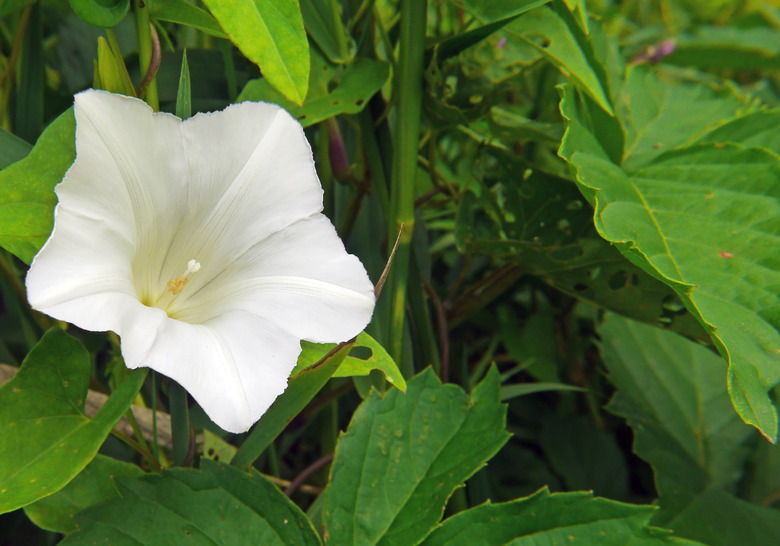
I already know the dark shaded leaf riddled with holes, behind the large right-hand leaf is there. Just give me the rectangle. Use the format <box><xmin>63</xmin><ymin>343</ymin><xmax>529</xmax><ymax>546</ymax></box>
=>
<box><xmin>455</xmin><ymin>151</ymin><xmax>707</xmax><ymax>340</ymax></box>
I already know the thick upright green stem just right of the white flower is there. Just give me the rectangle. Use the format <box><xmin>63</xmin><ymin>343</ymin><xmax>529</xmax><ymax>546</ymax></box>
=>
<box><xmin>388</xmin><ymin>0</ymin><xmax>428</xmax><ymax>363</ymax></box>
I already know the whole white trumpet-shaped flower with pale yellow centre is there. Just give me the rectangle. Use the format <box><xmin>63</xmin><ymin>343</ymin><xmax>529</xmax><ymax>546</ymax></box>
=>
<box><xmin>27</xmin><ymin>91</ymin><xmax>374</xmax><ymax>432</ymax></box>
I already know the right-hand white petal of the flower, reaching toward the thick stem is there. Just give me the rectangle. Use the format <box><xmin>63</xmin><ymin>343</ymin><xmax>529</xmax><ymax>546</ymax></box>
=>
<box><xmin>171</xmin><ymin>214</ymin><xmax>375</xmax><ymax>342</ymax></box>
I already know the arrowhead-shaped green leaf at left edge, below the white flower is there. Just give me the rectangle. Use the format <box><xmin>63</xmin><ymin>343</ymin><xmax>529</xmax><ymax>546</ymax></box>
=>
<box><xmin>0</xmin><ymin>328</ymin><xmax>146</xmax><ymax>513</ymax></box>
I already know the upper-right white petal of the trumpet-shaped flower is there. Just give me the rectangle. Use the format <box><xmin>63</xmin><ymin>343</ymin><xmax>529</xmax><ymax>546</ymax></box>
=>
<box><xmin>170</xmin><ymin>102</ymin><xmax>322</xmax><ymax>275</ymax></box>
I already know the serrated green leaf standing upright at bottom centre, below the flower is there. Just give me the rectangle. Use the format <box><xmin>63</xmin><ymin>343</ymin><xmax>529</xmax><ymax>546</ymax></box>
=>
<box><xmin>322</xmin><ymin>369</ymin><xmax>509</xmax><ymax>545</ymax></box>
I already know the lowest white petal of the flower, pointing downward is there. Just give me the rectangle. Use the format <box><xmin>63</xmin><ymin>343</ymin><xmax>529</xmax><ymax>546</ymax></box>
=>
<box><xmin>120</xmin><ymin>308</ymin><xmax>301</xmax><ymax>433</ymax></box>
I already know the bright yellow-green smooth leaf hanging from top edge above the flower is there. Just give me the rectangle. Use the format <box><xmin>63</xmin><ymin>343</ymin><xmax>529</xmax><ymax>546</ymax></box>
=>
<box><xmin>204</xmin><ymin>0</ymin><xmax>309</xmax><ymax>105</ymax></box>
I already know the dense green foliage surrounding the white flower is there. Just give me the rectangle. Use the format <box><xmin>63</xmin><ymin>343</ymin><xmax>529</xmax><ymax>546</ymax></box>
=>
<box><xmin>0</xmin><ymin>0</ymin><xmax>780</xmax><ymax>545</ymax></box>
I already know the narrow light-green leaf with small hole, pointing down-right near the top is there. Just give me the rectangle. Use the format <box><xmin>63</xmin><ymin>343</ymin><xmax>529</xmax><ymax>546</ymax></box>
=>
<box><xmin>506</xmin><ymin>3</ymin><xmax>614</xmax><ymax>115</ymax></box>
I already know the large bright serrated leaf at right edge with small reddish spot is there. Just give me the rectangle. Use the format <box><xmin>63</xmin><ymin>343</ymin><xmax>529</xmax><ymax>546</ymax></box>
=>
<box><xmin>560</xmin><ymin>78</ymin><xmax>780</xmax><ymax>441</ymax></box>
